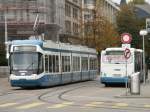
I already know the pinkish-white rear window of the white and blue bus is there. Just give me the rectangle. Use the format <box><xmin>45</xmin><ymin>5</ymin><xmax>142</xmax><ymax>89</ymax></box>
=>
<box><xmin>102</xmin><ymin>51</ymin><xmax>132</xmax><ymax>64</ymax></box>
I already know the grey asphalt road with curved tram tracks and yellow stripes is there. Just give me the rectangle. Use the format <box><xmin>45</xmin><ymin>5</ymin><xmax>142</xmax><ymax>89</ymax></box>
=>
<box><xmin>0</xmin><ymin>78</ymin><xmax>150</xmax><ymax>112</ymax></box>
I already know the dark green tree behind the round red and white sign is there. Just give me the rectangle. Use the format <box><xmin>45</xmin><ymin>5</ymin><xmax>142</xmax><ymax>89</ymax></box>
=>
<box><xmin>117</xmin><ymin>5</ymin><xmax>142</xmax><ymax>48</ymax></box>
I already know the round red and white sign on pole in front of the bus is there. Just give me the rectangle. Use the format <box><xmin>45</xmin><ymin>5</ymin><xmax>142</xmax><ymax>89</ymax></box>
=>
<box><xmin>121</xmin><ymin>33</ymin><xmax>132</xmax><ymax>44</ymax></box>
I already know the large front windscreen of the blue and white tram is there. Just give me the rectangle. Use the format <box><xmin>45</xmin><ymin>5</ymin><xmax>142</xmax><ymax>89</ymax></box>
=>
<box><xmin>10</xmin><ymin>52</ymin><xmax>42</xmax><ymax>73</ymax></box>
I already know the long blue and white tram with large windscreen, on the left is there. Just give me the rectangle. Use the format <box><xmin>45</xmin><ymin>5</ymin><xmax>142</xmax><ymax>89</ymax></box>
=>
<box><xmin>9</xmin><ymin>40</ymin><xmax>97</xmax><ymax>87</ymax></box>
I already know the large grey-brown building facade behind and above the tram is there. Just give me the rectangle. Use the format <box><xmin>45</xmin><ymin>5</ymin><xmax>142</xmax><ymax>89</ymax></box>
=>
<box><xmin>0</xmin><ymin>0</ymin><xmax>82</xmax><ymax>43</ymax></box>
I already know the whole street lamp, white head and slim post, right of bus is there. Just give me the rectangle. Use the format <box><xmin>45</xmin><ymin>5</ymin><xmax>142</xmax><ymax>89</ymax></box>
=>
<box><xmin>140</xmin><ymin>29</ymin><xmax>147</xmax><ymax>84</ymax></box>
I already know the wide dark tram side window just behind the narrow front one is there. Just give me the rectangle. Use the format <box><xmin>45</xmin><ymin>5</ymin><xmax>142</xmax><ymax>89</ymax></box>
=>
<box><xmin>49</xmin><ymin>55</ymin><xmax>59</xmax><ymax>73</ymax></box>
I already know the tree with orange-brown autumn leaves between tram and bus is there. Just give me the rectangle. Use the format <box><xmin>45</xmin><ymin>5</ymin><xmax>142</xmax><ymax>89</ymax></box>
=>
<box><xmin>85</xmin><ymin>0</ymin><xmax>120</xmax><ymax>52</ymax></box>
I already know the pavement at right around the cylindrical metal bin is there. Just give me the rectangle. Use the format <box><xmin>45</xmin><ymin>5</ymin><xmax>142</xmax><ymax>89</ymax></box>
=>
<box><xmin>115</xmin><ymin>70</ymin><xmax>150</xmax><ymax>98</ymax></box>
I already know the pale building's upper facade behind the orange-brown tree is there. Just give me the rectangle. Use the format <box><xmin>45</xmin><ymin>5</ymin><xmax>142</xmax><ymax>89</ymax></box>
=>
<box><xmin>83</xmin><ymin>0</ymin><xmax>120</xmax><ymax>24</ymax></box>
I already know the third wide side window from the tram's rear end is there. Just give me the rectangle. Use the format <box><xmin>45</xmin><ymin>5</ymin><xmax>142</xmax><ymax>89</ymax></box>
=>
<box><xmin>72</xmin><ymin>56</ymin><xmax>80</xmax><ymax>71</ymax></box>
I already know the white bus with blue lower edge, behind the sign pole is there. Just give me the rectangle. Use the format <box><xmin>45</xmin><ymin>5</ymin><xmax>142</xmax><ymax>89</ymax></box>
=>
<box><xmin>100</xmin><ymin>48</ymin><xmax>144</xmax><ymax>85</ymax></box>
